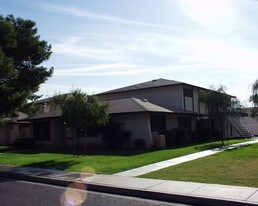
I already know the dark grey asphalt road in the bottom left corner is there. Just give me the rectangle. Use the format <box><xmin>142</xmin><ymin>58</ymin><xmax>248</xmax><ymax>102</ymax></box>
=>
<box><xmin>0</xmin><ymin>178</ymin><xmax>190</xmax><ymax>206</ymax></box>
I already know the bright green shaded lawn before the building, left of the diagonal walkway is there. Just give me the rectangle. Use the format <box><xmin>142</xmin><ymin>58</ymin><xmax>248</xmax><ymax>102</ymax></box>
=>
<box><xmin>0</xmin><ymin>140</ymin><xmax>249</xmax><ymax>174</ymax></box>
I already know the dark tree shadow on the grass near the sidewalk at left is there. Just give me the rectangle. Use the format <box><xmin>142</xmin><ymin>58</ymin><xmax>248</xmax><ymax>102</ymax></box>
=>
<box><xmin>22</xmin><ymin>160</ymin><xmax>79</xmax><ymax>170</ymax></box>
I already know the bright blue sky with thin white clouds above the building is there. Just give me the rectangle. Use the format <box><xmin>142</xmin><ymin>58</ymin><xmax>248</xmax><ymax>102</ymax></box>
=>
<box><xmin>0</xmin><ymin>0</ymin><xmax>258</xmax><ymax>103</ymax></box>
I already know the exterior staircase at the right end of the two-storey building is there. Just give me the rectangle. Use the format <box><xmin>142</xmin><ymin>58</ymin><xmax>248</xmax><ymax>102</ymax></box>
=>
<box><xmin>227</xmin><ymin>113</ymin><xmax>253</xmax><ymax>138</ymax></box>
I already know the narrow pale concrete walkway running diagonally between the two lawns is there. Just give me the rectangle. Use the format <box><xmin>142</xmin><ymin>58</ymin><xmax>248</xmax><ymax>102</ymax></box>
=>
<box><xmin>115</xmin><ymin>138</ymin><xmax>258</xmax><ymax>177</ymax></box>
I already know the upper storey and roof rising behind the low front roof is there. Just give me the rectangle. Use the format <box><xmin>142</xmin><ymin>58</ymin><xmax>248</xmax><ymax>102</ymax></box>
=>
<box><xmin>98</xmin><ymin>79</ymin><xmax>207</xmax><ymax>114</ymax></box>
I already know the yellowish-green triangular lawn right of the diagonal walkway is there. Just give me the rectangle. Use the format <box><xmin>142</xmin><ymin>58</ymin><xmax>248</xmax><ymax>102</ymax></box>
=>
<box><xmin>141</xmin><ymin>144</ymin><xmax>258</xmax><ymax>187</ymax></box>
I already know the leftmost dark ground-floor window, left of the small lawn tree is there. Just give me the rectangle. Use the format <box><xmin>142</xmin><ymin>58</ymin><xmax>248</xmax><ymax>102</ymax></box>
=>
<box><xmin>33</xmin><ymin>120</ymin><xmax>50</xmax><ymax>140</ymax></box>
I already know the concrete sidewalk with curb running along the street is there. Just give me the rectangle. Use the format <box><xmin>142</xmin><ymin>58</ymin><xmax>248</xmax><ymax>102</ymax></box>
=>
<box><xmin>0</xmin><ymin>166</ymin><xmax>258</xmax><ymax>206</ymax></box>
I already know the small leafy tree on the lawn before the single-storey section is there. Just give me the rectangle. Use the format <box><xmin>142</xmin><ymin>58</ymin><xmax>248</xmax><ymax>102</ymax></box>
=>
<box><xmin>52</xmin><ymin>90</ymin><xmax>109</xmax><ymax>155</ymax></box>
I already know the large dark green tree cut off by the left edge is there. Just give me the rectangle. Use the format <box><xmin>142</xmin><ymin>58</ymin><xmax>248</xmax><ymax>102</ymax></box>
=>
<box><xmin>0</xmin><ymin>15</ymin><xmax>53</xmax><ymax>124</ymax></box>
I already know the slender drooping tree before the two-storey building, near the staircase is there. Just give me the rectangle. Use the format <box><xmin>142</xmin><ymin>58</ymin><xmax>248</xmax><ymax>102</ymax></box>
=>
<box><xmin>200</xmin><ymin>86</ymin><xmax>232</xmax><ymax>143</ymax></box>
